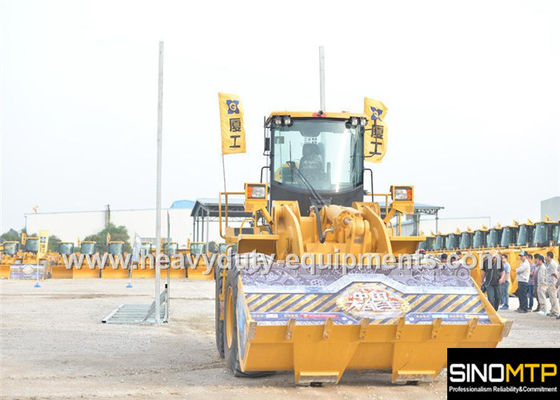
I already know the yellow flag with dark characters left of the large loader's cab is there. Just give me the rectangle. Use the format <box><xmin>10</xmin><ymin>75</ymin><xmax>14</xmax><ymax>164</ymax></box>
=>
<box><xmin>218</xmin><ymin>93</ymin><xmax>245</xmax><ymax>154</ymax></box>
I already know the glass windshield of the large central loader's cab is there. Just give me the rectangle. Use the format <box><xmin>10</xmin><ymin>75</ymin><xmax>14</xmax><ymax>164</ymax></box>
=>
<box><xmin>272</xmin><ymin>118</ymin><xmax>364</xmax><ymax>192</ymax></box>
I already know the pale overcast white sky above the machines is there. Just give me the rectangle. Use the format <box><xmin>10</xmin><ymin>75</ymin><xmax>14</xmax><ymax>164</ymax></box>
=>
<box><xmin>0</xmin><ymin>0</ymin><xmax>560</xmax><ymax>231</ymax></box>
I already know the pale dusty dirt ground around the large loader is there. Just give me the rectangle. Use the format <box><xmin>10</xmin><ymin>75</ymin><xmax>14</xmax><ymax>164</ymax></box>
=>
<box><xmin>0</xmin><ymin>279</ymin><xmax>560</xmax><ymax>400</ymax></box>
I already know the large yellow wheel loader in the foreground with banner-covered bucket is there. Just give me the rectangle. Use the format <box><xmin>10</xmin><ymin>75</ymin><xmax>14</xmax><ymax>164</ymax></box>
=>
<box><xmin>216</xmin><ymin>112</ymin><xmax>511</xmax><ymax>384</ymax></box>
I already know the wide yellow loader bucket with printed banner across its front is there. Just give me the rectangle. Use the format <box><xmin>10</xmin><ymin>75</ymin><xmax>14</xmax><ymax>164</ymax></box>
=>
<box><xmin>234</xmin><ymin>263</ymin><xmax>511</xmax><ymax>384</ymax></box>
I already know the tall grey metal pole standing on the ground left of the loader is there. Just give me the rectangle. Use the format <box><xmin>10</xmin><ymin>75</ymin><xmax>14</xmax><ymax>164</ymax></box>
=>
<box><xmin>154</xmin><ymin>41</ymin><xmax>163</xmax><ymax>325</ymax></box>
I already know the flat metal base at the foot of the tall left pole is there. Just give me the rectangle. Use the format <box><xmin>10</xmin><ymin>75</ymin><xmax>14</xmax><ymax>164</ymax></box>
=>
<box><xmin>101</xmin><ymin>285</ymin><xmax>169</xmax><ymax>325</ymax></box>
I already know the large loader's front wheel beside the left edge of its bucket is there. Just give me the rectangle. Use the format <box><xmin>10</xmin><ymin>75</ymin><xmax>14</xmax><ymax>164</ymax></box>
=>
<box><xmin>223</xmin><ymin>262</ymin><xmax>274</xmax><ymax>378</ymax></box>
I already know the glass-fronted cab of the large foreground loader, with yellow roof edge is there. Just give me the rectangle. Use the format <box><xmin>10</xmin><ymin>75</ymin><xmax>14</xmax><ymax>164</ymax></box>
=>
<box><xmin>265</xmin><ymin>112</ymin><xmax>366</xmax><ymax>216</ymax></box>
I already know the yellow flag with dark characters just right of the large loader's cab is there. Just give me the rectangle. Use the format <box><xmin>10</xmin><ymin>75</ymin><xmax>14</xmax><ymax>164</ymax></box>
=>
<box><xmin>364</xmin><ymin>97</ymin><xmax>387</xmax><ymax>163</ymax></box>
